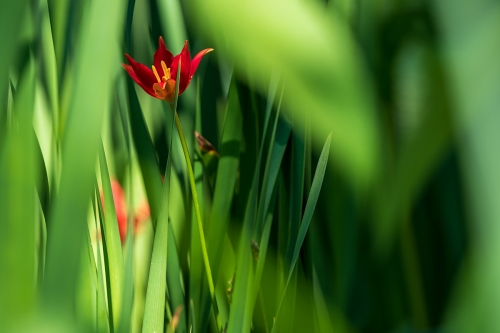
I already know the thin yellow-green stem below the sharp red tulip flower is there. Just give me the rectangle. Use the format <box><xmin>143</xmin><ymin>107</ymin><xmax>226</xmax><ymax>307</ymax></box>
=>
<box><xmin>172</xmin><ymin>109</ymin><xmax>222</xmax><ymax>332</ymax></box>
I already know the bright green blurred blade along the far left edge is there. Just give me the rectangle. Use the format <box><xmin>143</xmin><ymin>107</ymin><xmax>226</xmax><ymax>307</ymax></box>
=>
<box><xmin>0</xmin><ymin>53</ymin><xmax>38</xmax><ymax>331</ymax></box>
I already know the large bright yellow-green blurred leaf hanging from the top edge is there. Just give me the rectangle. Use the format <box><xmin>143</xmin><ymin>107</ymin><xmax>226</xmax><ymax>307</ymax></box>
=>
<box><xmin>190</xmin><ymin>0</ymin><xmax>380</xmax><ymax>187</ymax></box>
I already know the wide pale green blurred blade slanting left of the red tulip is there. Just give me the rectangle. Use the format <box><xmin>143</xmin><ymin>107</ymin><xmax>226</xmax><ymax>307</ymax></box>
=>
<box><xmin>44</xmin><ymin>0</ymin><xmax>123</xmax><ymax>311</ymax></box>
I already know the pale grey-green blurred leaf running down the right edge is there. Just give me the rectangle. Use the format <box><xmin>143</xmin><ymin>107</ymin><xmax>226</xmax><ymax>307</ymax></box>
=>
<box><xmin>435</xmin><ymin>0</ymin><xmax>500</xmax><ymax>332</ymax></box>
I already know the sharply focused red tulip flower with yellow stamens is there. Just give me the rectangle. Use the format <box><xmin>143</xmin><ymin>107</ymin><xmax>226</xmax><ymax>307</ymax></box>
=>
<box><xmin>123</xmin><ymin>37</ymin><xmax>213</xmax><ymax>102</ymax></box>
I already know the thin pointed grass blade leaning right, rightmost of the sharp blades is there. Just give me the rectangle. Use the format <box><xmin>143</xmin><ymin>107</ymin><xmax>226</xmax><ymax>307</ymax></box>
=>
<box><xmin>272</xmin><ymin>135</ymin><xmax>331</xmax><ymax>332</ymax></box>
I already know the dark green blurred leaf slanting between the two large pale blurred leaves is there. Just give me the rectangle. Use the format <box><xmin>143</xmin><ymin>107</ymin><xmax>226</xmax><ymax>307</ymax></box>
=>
<box><xmin>373</xmin><ymin>45</ymin><xmax>452</xmax><ymax>255</ymax></box>
